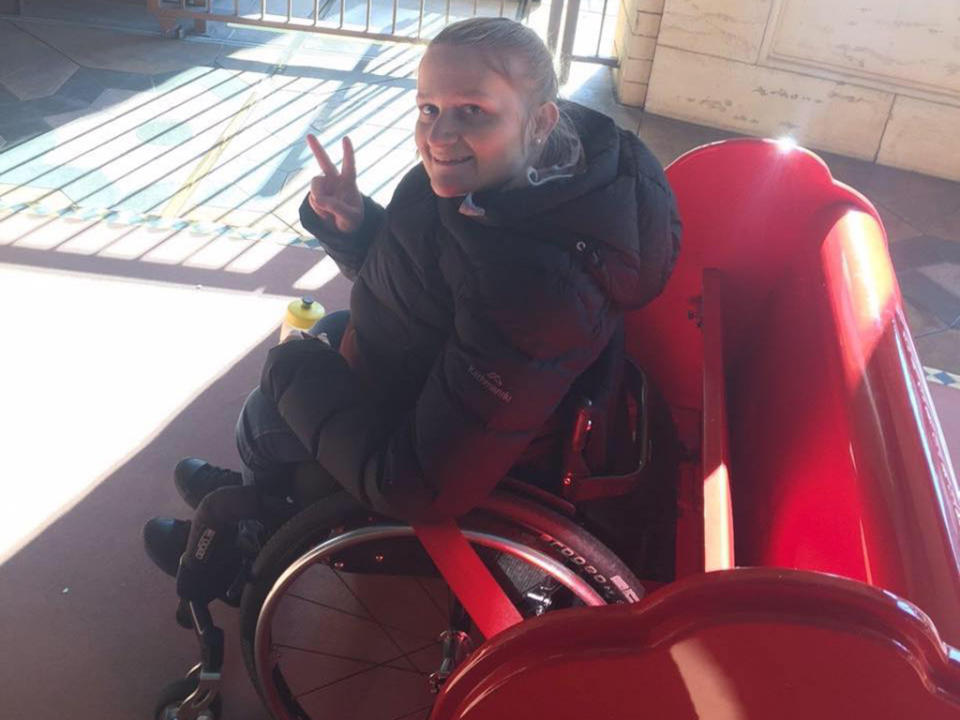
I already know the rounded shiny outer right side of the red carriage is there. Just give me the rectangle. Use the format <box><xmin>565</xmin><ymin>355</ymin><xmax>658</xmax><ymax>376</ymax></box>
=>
<box><xmin>821</xmin><ymin>213</ymin><xmax>960</xmax><ymax>644</ymax></box>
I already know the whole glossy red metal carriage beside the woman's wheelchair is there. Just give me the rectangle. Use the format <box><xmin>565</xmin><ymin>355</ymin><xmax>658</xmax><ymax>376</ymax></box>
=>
<box><xmin>420</xmin><ymin>140</ymin><xmax>960</xmax><ymax>720</ymax></box>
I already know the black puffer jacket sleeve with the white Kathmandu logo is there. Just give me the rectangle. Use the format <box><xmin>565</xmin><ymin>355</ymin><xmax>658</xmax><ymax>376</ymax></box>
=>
<box><xmin>261</xmin><ymin>258</ymin><xmax>616</xmax><ymax>522</ymax></box>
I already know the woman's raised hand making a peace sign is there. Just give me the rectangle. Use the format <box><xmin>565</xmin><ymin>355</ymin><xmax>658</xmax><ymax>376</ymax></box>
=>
<box><xmin>307</xmin><ymin>135</ymin><xmax>363</xmax><ymax>233</ymax></box>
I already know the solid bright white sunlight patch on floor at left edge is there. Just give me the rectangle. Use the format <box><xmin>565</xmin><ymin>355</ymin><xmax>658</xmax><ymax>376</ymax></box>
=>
<box><xmin>0</xmin><ymin>264</ymin><xmax>289</xmax><ymax>561</ymax></box>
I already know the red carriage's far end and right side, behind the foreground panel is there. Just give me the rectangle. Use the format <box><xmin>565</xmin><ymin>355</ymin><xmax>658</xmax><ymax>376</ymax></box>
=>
<box><xmin>628</xmin><ymin>140</ymin><xmax>960</xmax><ymax>644</ymax></box>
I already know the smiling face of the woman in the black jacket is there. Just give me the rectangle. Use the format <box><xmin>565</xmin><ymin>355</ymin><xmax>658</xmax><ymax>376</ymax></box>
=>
<box><xmin>416</xmin><ymin>44</ymin><xmax>556</xmax><ymax>197</ymax></box>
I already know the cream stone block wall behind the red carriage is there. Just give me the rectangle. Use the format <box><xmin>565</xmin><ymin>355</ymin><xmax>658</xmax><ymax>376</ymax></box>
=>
<box><xmin>617</xmin><ymin>0</ymin><xmax>960</xmax><ymax>180</ymax></box>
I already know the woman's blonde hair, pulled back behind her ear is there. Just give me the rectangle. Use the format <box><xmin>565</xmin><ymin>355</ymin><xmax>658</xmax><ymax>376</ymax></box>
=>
<box><xmin>428</xmin><ymin>17</ymin><xmax>581</xmax><ymax>167</ymax></box>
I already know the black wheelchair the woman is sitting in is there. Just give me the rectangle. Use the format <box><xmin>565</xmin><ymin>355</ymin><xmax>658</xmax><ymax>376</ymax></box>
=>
<box><xmin>154</xmin><ymin>356</ymin><xmax>678</xmax><ymax>720</ymax></box>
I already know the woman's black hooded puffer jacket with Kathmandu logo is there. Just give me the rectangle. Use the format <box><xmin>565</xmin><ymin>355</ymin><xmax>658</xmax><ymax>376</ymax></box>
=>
<box><xmin>261</xmin><ymin>103</ymin><xmax>680</xmax><ymax>521</ymax></box>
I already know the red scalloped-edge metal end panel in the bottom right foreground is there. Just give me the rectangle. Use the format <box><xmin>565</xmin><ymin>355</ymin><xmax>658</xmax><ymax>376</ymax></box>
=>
<box><xmin>431</xmin><ymin>569</ymin><xmax>960</xmax><ymax>720</ymax></box>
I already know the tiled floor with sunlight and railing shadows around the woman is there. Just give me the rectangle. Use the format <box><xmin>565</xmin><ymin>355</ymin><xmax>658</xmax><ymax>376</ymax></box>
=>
<box><xmin>0</xmin><ymin>1</ymin><xmax>960</xmax><ymax>720</ymax></box>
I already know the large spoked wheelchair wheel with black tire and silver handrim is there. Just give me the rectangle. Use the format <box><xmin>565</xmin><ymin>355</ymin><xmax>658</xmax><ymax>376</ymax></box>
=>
<box><xmin>241</xmin><ymin>493</ymin><xmax>643</xmax><ymax>720</ymax></box>
